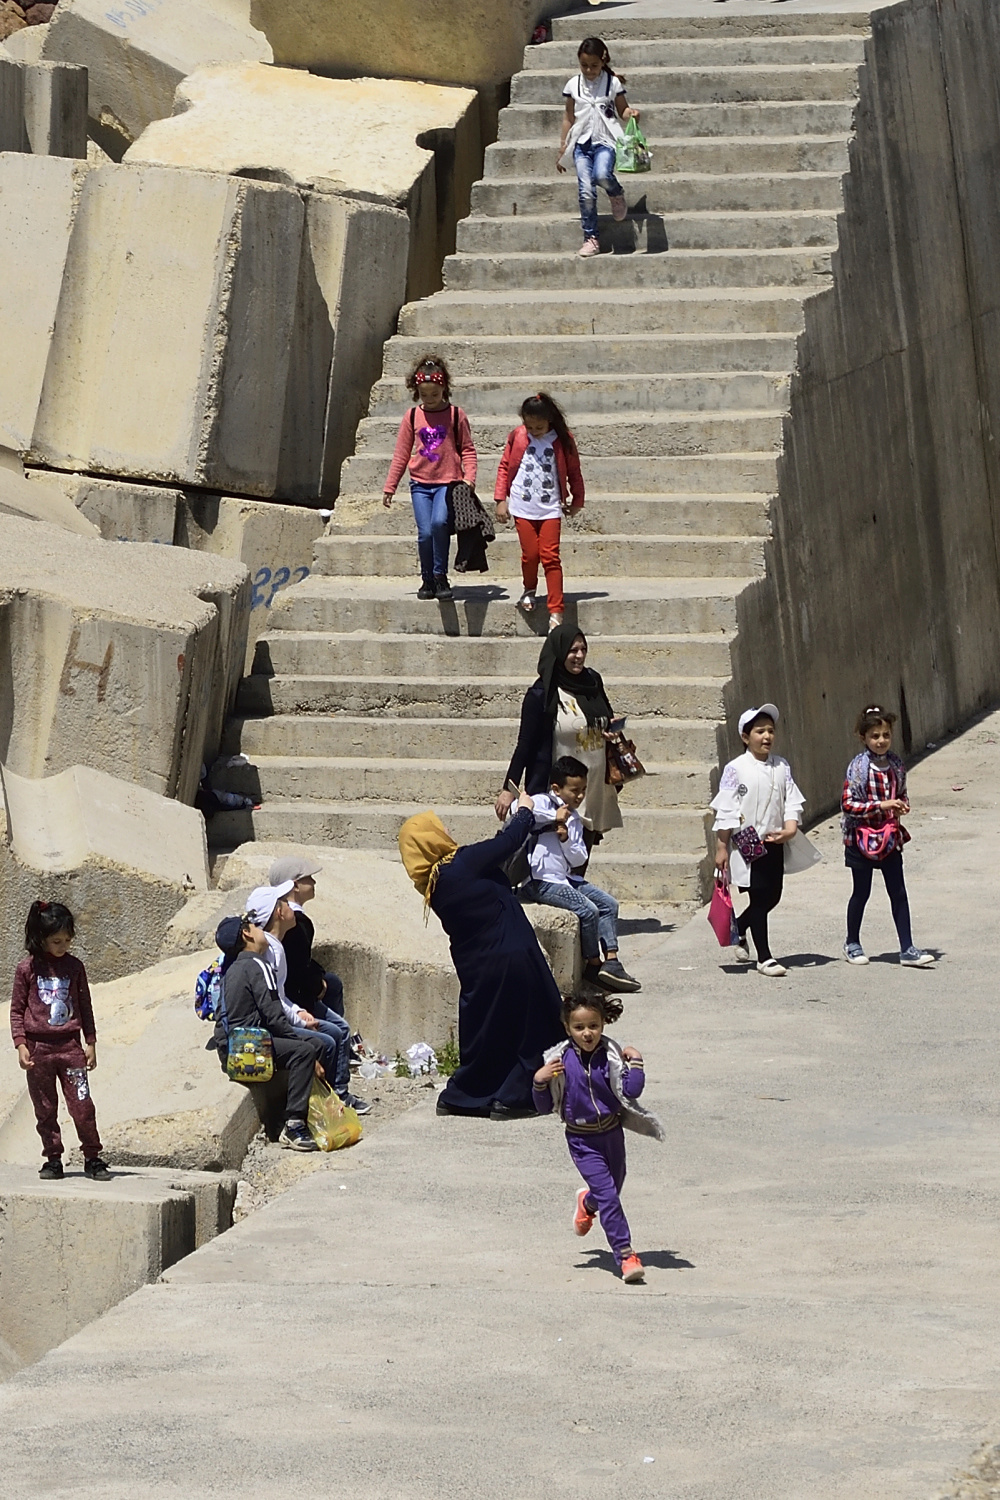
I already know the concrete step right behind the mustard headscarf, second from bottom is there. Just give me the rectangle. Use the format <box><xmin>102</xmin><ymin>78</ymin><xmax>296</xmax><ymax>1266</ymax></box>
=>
<box><xmin>203</xmin><ymin>800</ymin><xmax>706</xmax><ymax>855</ymax></box>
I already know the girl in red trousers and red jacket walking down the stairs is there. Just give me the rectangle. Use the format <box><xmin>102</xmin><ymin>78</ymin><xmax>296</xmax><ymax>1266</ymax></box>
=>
<box><xmin>493</xmin><ymin>390</ymin><xmax>583</xmax><ymax>630</ymax></box>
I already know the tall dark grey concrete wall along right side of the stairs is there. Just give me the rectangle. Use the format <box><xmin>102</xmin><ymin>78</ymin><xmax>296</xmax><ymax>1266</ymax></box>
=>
<box><xmin>721</xmin><ymin>0</ymin><xmax>1000</xmax><ymax>816</ymax></box>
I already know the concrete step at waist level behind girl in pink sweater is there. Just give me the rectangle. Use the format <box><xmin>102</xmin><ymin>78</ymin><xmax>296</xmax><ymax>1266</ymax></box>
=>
<box><xmin>340</xmin><ymin>443</ymin><xmax>777</xmax><ymax>500</ymax></box>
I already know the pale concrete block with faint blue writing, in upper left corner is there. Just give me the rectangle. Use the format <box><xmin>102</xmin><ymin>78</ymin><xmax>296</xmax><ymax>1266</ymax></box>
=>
<box><xmin>43</xmin><ymin>0</ymin><xmax>271</xmax><ymax>152</ymax></box>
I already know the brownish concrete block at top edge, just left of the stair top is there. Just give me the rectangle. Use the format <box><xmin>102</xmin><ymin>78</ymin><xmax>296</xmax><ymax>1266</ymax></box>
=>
<box><xmin>250</xmin><ymin>0</ymin><xmax>548</xmax><ymax>89</ymax></box>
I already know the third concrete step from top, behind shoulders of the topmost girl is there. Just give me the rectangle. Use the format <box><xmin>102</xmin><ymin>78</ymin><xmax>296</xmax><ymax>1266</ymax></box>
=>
<box><xmin>510</xmin><ymin>63</ymin><xmax>858</xmax><ymax>110</ymax></box>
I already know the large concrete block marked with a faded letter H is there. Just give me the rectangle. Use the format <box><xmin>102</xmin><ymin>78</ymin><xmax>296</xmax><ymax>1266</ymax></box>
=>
<box><xmin>0</xmin><ymin>510</ymin><xmax>250</xmax><ymax>801</ymax></box>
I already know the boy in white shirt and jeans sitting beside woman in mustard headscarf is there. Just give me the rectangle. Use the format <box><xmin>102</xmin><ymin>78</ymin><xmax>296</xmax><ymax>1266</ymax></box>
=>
<box><xmin>528</xmin><ymin>755</ymin><xmax>642</xmax><ymax>995</ymax></box>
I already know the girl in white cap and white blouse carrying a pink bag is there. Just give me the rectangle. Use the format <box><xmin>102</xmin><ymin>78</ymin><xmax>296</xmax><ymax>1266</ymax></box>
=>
<box><xmin>712</xmin><ymin>704</ymin><xmax>805</xmax><ymax>980</ymax></box>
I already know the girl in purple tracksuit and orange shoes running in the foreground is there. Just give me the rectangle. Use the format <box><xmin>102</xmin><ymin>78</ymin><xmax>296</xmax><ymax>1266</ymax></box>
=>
<box><xmin>532</xmin><ymin>996</ymin><xmax>663</xmax><ymax>1281</ymax></box>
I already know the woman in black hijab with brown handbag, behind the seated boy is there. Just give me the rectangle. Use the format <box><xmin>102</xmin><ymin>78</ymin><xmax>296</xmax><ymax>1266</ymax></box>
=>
<box><xmin>496</xmin><ymin>626</ymin><xmax>622</xmax><ymax>843</ymax></box>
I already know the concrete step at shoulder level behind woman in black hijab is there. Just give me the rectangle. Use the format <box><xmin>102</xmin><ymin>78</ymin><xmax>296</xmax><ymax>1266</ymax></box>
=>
<box><xmin>237</xmin><ymin>674</ymin><xmax>724</xmax><ymax>722</ymax></box>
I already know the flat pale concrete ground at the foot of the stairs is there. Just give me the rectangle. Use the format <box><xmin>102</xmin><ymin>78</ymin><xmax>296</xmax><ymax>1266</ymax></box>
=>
<box><xmin>0</xmin><ymin>713</ymin><xmax>1000</xmax><ymax>1500</ymax></box>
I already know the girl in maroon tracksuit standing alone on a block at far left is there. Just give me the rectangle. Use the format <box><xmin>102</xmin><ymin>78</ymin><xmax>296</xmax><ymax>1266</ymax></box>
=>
<box><xmin>10</xmin><ymin>902</ymin><xmax>111</xmax><ymax>1182</ymax></box>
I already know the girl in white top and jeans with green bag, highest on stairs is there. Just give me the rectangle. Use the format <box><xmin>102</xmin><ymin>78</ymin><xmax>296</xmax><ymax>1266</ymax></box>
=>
<box><xmin>556</xmin><ymin>36</ymin><xmax>639</xmax><ymax>257</ymax></box>
